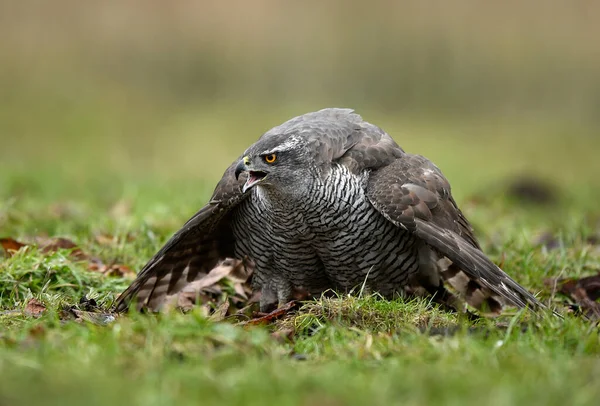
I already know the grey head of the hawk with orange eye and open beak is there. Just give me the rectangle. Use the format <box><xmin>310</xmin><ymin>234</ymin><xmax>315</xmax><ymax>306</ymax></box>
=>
<box><xmin>235</xmin><ymin>109</ymin><xmax>362</xmax><ymax>197</ymax></box>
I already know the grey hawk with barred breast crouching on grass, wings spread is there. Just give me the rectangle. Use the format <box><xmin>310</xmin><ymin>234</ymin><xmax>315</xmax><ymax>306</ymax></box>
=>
<box><xmin>115</xmin><ymin>108</ymin><xmax>544</xmax><ymax>314</ymax></box>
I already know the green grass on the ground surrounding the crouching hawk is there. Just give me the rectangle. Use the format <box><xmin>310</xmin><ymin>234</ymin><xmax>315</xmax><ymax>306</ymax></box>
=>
<box><xmin>0</xmin><ymin>111</ymin><xmax>600</xmax><ymax>406</ymax></box>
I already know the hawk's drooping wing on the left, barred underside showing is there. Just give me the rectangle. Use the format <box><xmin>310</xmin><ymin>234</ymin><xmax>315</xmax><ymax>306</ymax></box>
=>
<box><xmin>115</xmin><ymin>161</ymin><xmax>248</xmax><ymax>312</ymax></box>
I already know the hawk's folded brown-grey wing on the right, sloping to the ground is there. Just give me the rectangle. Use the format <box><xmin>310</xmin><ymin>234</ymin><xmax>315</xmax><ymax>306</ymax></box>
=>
<box><xmin>367</xmin><ymin>154</ymin><xmax>545</xmax><ymax>309</ymax></box>
